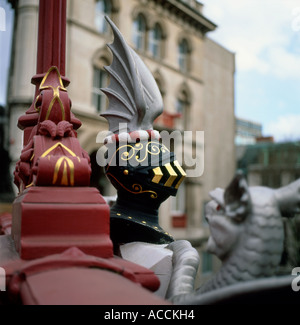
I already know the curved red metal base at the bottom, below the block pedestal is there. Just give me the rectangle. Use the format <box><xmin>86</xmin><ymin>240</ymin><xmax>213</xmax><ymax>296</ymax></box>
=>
<box><xmin>0</xmin><ymin>247</ymin><xmax>163</xmax><ymax>305</ymax></box>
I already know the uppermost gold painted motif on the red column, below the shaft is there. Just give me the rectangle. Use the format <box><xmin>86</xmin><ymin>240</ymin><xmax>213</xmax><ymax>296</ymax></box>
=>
<box><xmin>34</xmin><ymin>67</ymin><xmax>67</xmax><ymax>121</ymax></box>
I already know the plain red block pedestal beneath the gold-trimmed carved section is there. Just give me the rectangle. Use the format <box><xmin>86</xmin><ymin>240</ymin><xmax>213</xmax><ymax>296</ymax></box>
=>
<box><xmin>12</xmin><ymin>186</ymin><xmax>113</xmax><ymax>260</ymax></box>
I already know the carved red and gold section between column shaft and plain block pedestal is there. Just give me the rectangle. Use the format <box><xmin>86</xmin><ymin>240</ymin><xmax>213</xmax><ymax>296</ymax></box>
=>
<box><xmin>14</xmin><ymin>67</ymin><xmax>91</xmax><ymax>192</ymax></box>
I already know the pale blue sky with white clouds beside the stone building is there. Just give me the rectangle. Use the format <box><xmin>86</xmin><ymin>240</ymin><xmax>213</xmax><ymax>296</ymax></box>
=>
<box><xmin>200</xmin><ymin>0</ymin><xmax>300</xmax><ymax>142</ymax></box>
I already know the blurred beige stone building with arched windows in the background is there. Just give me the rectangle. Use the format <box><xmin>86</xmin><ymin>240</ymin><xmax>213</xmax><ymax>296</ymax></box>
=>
<box><xmin>8</xmin><ymin>0</ymin><xmax>235</xmax><ymax>271</ymax></box>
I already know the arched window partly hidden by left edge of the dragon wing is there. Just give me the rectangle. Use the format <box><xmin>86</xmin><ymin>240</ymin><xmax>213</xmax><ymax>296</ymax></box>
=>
<box><xmin>92</xmin><ymin>67</ymin><xmax>108</xmax><ymax>113</ymax></box>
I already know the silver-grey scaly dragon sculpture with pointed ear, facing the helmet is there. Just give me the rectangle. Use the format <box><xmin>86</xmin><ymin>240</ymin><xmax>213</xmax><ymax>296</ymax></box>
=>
<box><xmin>169</xmin><ymin>172</ymin><xmax>300</xmax><ymax>304</ymax></box>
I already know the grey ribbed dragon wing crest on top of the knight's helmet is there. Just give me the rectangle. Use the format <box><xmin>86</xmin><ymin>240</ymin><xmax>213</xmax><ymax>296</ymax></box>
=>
<box><xmin>101</xmin><ymin>16</ymin><xmax>163</xmax><ymax>133</ymax></box>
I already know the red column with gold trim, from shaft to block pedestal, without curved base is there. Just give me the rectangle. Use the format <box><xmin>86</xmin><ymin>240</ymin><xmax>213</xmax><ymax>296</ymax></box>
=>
<box><xmin>12</xmin><ymin>0</ymin><xmax>113</xmax><ymax>259</ymax></box>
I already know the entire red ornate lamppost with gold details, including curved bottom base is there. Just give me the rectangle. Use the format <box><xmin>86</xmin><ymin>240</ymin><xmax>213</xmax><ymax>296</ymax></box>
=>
<box><xmin>0</xmin><ymin>0</ymin><xmax>165</xmax><ymax>304</ymax></box>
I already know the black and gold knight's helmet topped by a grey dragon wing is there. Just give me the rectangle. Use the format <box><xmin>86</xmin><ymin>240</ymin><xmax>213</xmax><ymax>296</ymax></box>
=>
<box><xmin>102</xmin><ymin>17</ymin><xmax>186</xmax><ymax>251</ymax></box>
